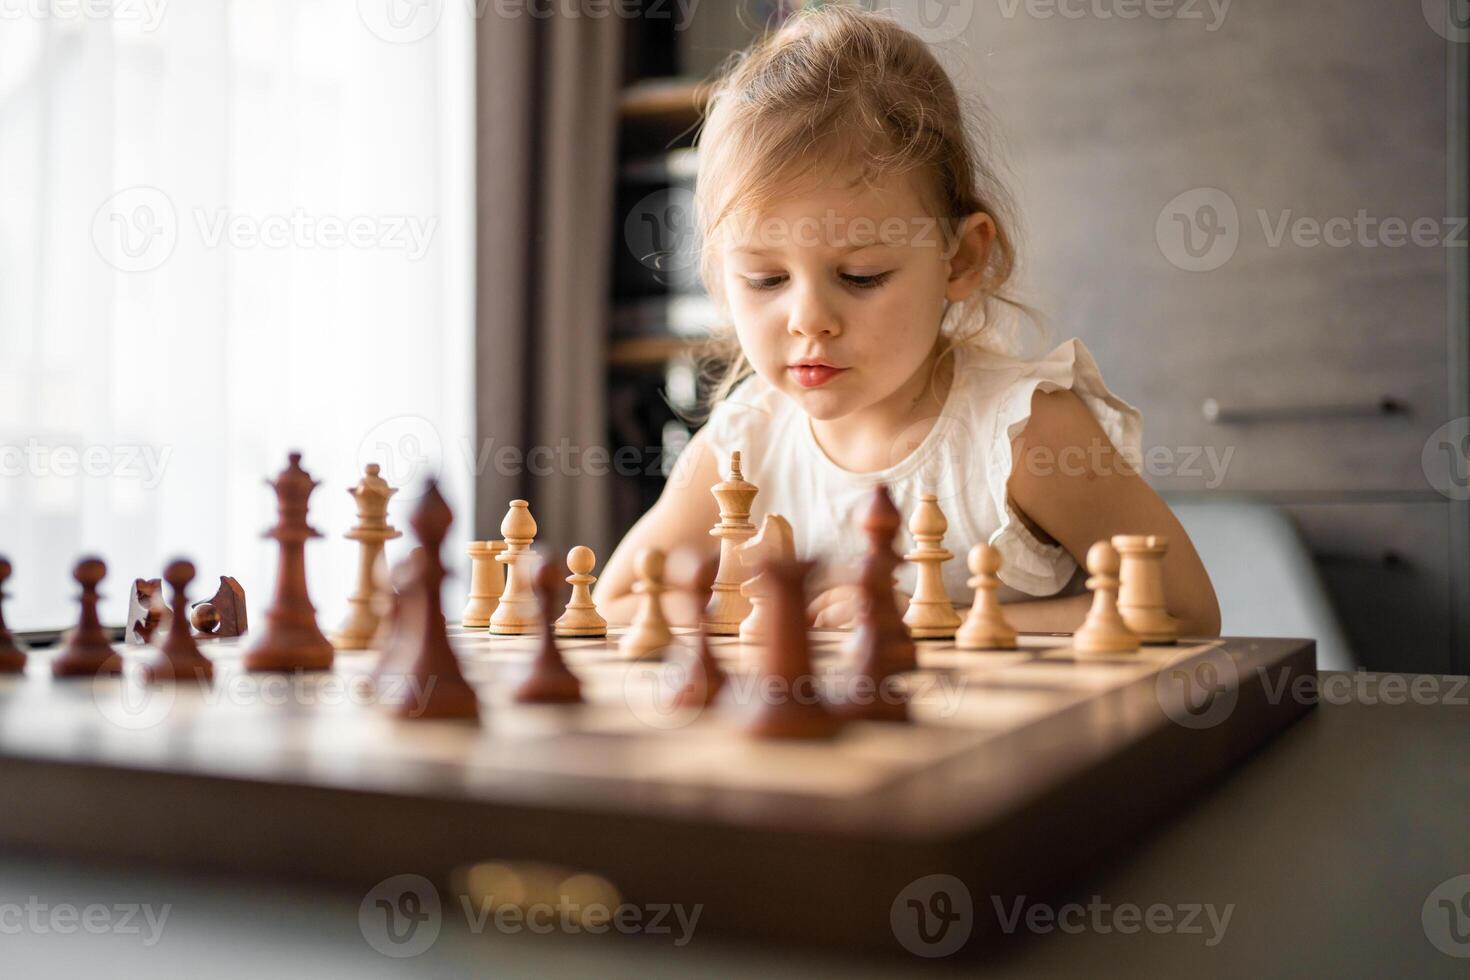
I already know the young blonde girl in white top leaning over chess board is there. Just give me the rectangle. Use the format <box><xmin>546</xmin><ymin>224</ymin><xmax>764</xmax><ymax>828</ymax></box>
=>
<box><xmin>597</xmin><ymin>6</ymin><xmax>1220</xmax><ymax>636</ymax></box>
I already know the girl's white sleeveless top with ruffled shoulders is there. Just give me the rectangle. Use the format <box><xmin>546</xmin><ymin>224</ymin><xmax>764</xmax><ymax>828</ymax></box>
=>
<box><xmin>704</xmin><ymin>339</ymin><xmax>1142</xmax><ymax>602</ymax></box>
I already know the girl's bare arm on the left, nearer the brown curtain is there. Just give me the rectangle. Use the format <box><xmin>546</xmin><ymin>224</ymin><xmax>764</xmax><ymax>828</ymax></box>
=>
<box><xmin>594</xmin><ymin>429</ymin><xmax>720</xmax><ymax>626</ymax></box>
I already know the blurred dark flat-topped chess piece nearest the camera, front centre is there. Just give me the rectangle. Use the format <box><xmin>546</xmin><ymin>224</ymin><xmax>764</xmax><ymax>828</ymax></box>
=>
<box><xmin>747</xmin><ymin>560</ymin><xmax>842</xmax><ymax>739</ymax></box>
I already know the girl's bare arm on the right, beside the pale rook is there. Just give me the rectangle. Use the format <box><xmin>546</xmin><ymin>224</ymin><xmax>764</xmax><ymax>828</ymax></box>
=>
<box><xmin>1005</xmin><ymin>389</ymin><xmax>1220</xmax><ymax>636</ymax></box>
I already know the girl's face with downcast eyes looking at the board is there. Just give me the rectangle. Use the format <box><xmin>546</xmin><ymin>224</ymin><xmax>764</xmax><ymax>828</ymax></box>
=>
<box><xmin>720</xmin><ymin>167</ymin><xmax>973</xmax><ymax>420</ymax></box>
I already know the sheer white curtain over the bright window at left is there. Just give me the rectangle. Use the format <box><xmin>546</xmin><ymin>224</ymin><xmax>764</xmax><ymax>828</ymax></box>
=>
<box><xmin>0</xmin><ymin>0</ymin><xmax>473</xmax><ymax>627</ymax></box>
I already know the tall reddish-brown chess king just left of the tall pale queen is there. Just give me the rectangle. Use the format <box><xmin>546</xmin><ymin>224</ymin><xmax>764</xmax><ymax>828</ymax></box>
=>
<box><xmin>243</xmin><ymin>453</ymin><xmax>332</xmax><ymax>671</ymax></box>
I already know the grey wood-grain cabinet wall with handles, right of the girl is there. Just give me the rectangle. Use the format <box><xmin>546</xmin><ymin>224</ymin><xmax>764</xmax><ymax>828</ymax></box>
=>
<box><xmin>938</xmin><ymin>0</ymin><xmax>1464</xmax><ymax>670</ymax></box>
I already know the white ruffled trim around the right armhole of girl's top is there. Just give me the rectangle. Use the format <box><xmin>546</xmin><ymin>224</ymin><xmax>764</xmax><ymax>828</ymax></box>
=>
<box><xmin>979</xmin><ymin>339</ymin><xmax>1144</xmax><ymax>597</ymax></box>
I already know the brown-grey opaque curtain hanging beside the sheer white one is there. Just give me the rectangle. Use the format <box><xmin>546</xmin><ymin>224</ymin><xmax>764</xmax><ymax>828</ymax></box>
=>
<box><xmin>473</xmin><ymin>15</ymin><xmax>625</xmax><ymax>561</ymax></box>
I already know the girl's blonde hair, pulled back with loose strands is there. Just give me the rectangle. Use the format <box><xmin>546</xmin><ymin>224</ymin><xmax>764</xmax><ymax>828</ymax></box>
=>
<box><xmin>694</xmin><ymin>4</ymin><xmax>1030</xmax><ymax>404</ymax></box>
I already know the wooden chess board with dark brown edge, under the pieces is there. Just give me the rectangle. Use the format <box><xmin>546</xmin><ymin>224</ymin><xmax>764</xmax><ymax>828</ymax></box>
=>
<box><xmin>0</xmin><ymin>629</ymin><xmax>1316</xmax><ymax>949</ymax></box>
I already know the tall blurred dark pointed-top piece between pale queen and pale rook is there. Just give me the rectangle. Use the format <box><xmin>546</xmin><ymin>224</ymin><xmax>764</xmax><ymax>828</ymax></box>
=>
<box><xmin>376</xmin><ymin>479</ymin><xmax>479</xmax><ymax>720</ymax></box>
